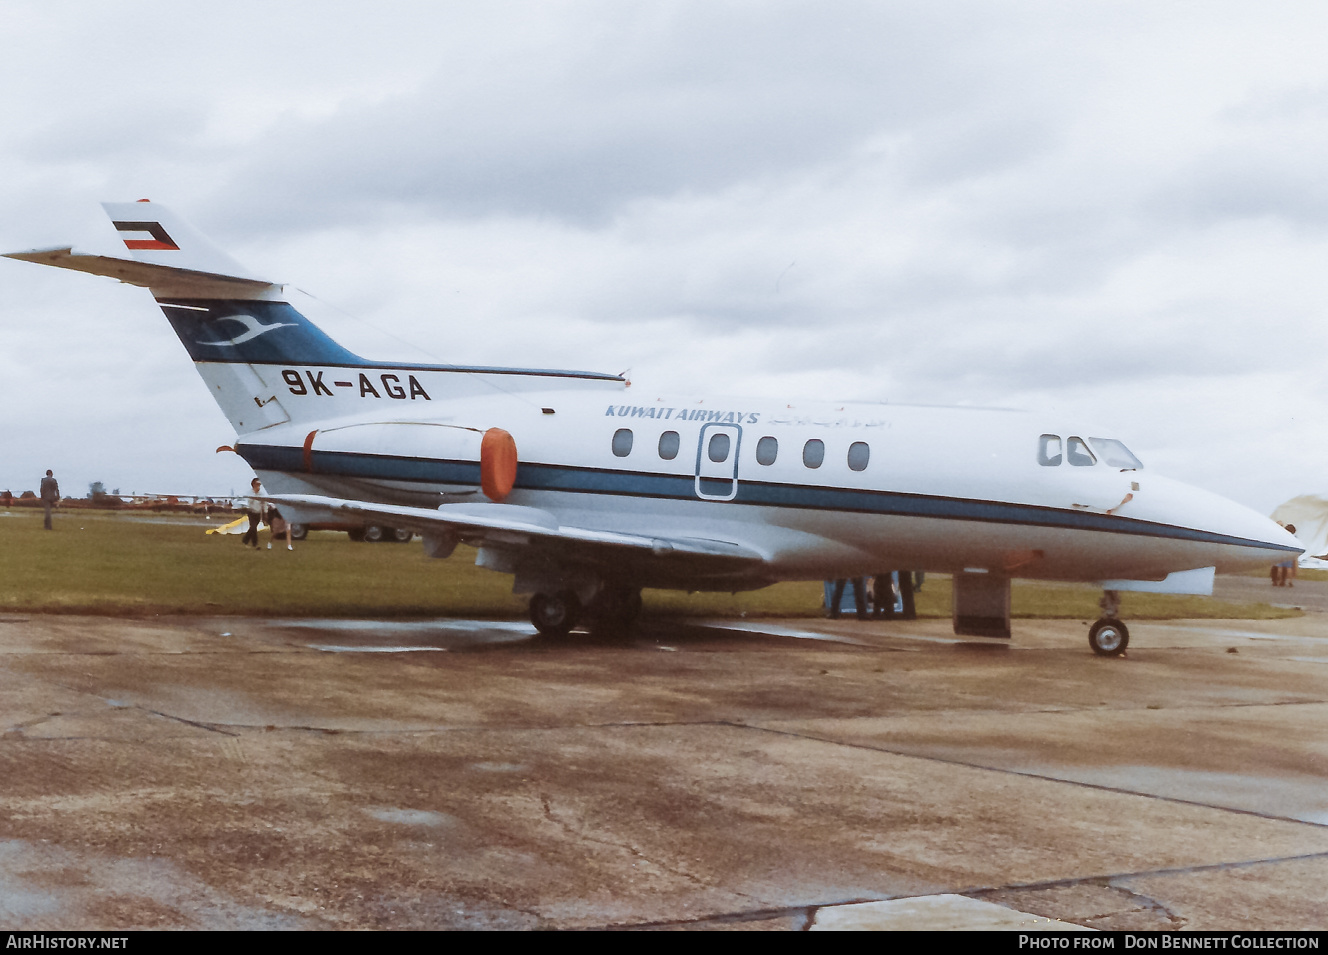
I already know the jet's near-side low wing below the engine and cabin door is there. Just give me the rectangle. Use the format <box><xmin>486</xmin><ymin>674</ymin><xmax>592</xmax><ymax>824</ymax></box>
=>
<box><xmin>263</xmin><ymin>494</ymin><xmax>766</xmax><ymax>571</ymax></box>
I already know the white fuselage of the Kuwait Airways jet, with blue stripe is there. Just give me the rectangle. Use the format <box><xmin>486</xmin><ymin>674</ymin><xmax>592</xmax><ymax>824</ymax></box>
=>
<box><xmin>220</xmin><ymin>363</ymin><xmax>1299</xmax><ymax>590</ymax></box>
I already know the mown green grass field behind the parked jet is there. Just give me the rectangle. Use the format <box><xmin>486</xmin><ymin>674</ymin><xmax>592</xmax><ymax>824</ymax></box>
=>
<box><xmin>0</xmin><ymin>507</ymin><xmax>1304</xmax><ymax>620</ymax></box>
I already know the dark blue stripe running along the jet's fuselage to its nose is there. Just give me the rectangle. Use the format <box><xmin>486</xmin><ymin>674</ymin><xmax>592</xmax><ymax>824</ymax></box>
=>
<box><xmin>238</xmin><ymin>444</ymin><xmax>1297</xmax><ymax>554</ymax></box>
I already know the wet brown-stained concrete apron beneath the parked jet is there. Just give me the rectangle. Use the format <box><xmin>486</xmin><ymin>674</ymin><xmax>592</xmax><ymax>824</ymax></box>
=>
<box><xmin>0</xmin><ymin>608</ymin><xmax>1328</xmax><ymax>930</ymax></box>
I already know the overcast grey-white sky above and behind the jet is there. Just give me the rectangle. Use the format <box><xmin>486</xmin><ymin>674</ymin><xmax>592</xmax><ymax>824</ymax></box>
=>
<box><xmin>0</xmin><ymin>0</ymin><xmax>1328</xmax><ymax>513</ymax></box>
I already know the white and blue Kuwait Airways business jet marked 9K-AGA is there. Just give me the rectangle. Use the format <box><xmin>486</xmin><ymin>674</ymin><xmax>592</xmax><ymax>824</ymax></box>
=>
<box><xmin>9</xmin><ymin>201</ymin><xmax>1303</xmax><ymax>656</ymax></box>
